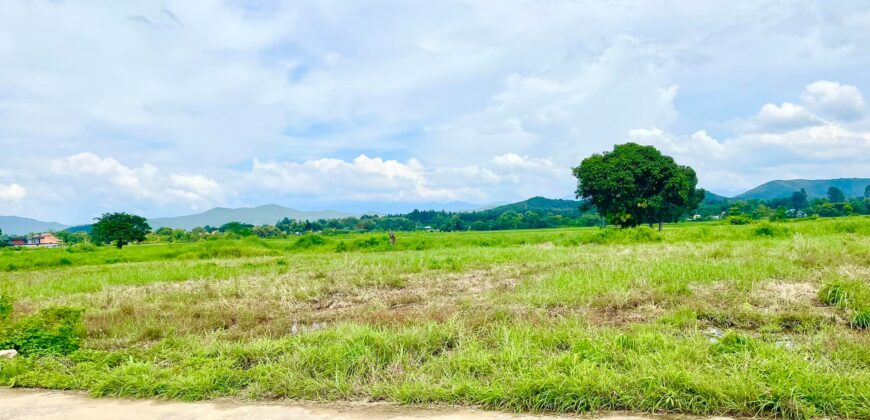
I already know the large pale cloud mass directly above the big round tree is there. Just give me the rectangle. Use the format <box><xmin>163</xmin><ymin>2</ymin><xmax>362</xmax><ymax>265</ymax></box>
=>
<box><xmin>422</xmin><ymin>36</ymin><xmax>677</xmax><ymax>164</ymax></box>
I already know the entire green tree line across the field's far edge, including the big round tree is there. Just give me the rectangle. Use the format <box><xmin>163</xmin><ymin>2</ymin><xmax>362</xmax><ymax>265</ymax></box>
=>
<box><xmin>0</xmin><ymin>143</ymin><xmax>870</xmax><ymax>248</ymax></box>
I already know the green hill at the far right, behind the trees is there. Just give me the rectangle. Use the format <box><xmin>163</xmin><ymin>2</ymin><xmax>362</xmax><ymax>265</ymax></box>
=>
<box><xmin>734</xmin><ymin>178</ymin><xmax>870</xmax><ymax>200</ymax></box>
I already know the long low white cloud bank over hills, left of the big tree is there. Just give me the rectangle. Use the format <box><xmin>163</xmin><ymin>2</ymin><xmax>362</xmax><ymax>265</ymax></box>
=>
<box><xmin>246</xmin><ymin>154</ymin><xmax>571</xmax><ymax>202</ymax></box>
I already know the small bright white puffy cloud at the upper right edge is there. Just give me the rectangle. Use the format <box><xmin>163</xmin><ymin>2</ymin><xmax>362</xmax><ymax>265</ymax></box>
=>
<box><xmin>801</xmin><ymin>80</ymin><xmax>866</xmax><ymax>121</ymax></box>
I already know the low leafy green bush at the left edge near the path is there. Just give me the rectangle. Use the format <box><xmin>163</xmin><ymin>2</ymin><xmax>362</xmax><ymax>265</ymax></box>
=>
<box><xmin>0</xmin><ymin>307</ymin><xmax>84</xmax><ymax>356</ymax></box>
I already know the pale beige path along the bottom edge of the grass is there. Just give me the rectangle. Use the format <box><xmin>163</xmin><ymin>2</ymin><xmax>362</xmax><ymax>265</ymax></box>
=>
<box><xmin>0</xmin><ymin>388</ymin><xmax>716</xmax><ymax>420</ymax></box>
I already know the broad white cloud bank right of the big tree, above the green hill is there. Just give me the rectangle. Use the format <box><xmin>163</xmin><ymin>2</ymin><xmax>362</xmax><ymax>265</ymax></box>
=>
<box><xmin>630</xmin><ymin>82</ymin><xmax>870</xmax><ymax>192</ymax></box>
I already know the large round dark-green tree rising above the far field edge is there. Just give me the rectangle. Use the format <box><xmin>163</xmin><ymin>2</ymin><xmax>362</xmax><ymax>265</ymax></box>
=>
<box><xmin>574</xmin><ymin>143</ymin><xmax>704</xmax><ymax>230</ymax></box>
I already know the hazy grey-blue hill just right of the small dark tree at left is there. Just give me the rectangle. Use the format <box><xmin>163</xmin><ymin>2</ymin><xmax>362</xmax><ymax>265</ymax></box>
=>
<box><xmin>148</xmin><ymin>204</ymin><xmax>355</xmax><ymax>230</ymax></box>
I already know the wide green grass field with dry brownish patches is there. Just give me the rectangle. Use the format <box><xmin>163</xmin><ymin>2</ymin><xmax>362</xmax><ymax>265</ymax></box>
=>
<box><xmin>0</xmin><ymin>217</ymin><xmax>870</xmax><ymax>418</ymax></box>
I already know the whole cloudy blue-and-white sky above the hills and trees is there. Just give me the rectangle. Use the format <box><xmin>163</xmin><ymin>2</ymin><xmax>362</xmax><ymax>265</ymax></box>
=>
<box><xmin>0</xmin><ymin>0</ymin><xmax>870</xmax><ymax>224</ymax></box>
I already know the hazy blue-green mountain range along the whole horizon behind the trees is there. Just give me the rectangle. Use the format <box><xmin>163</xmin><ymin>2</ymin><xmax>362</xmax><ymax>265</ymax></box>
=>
<box><xmin>0</xmin><ymin>178</ymin><xmax>870</xmax><ymax>235</ymax></box>
